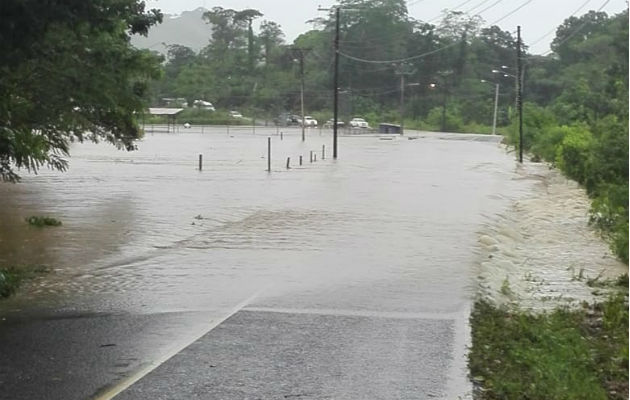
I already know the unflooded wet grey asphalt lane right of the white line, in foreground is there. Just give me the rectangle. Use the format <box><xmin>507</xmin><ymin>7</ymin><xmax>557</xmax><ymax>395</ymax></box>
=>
<box><xmin>117</xmin><ymin>311</ymin><xmax>454</xmax><ymax>400</ymax></box>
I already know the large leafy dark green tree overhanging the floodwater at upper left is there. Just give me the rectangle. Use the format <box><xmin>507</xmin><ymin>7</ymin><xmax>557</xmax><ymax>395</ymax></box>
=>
<box><xmin>0</xmin><ymin>0</ymin><xmax>162</xmax><ymax>181</ymax></box>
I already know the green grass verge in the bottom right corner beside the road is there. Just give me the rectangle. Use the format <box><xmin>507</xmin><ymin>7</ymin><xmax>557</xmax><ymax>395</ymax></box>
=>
<box><xmin>468</xmin><ymin>295</ymin><xmax>628</xmax><ymax>400</ymax></box>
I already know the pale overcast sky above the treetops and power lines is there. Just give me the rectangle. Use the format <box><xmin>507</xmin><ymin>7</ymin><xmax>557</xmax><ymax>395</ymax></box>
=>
<box><xmin>145</xmin><ymin>0</ymin><xmax>627</xmax><ymax>54</ymax></box>
